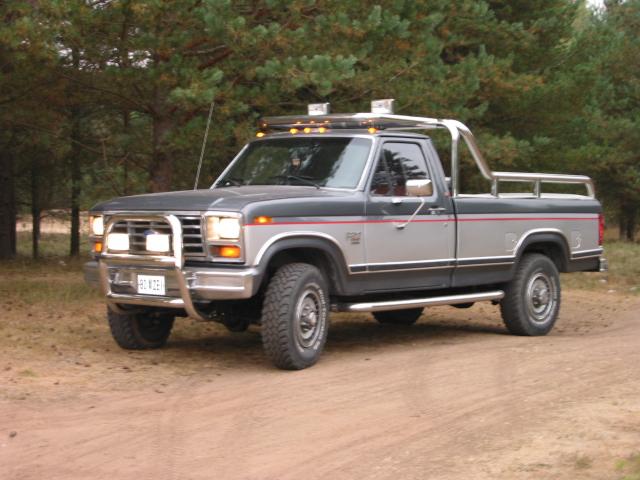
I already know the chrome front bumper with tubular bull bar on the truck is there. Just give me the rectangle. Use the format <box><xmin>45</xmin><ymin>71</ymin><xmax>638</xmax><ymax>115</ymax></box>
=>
<box><xmin>84</xmin><ymin>215</ymin><xmax>260</xmax><ymax>319</ymax></box>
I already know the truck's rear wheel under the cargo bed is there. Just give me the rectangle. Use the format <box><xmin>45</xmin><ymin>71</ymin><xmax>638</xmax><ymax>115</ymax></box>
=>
<box><xmin>500</xmin><ymin>253</ymin><xmax>560</xmax><ymax>336</ymax></box>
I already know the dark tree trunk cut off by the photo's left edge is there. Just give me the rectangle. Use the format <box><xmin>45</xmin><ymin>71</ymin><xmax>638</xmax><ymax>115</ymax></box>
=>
<box><xmin>0</xmin><ymin>145</ymin><xmax>16</xmax><ymax>259</ymax></box>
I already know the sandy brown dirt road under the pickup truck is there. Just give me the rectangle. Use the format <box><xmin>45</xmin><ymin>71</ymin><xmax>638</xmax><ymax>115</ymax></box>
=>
<box><xmin>0</xmin><ymin>291</ymin><xmax>640</xmax><ymax>480</ymax></box>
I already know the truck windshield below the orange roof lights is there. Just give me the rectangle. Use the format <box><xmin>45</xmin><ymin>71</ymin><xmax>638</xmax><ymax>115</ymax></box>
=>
<box><xmin>216</xmin><ymin>137</ymin><xmax>371</xmax><ymax>189</ymax></box>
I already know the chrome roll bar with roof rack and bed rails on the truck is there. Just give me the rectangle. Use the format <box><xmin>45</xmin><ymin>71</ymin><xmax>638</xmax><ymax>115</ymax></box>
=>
<box><xmin>259</xmin><ymin>113</ymin><xmax>595</xmax><ymax>198</ymax></box>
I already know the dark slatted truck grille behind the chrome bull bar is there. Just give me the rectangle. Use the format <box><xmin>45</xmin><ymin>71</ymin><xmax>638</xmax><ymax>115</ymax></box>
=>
<box><xmin>112</xmin><ymin>216</ymin><xmax>206</xmax><ymax>258</ymax></box>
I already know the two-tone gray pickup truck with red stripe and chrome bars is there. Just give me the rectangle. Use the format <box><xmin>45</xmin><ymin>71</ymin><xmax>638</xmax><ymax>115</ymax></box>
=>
<box><xmin>85</xmin><ymin>100</ymin><xmax>606</xmax><ymax>369</ymax></box>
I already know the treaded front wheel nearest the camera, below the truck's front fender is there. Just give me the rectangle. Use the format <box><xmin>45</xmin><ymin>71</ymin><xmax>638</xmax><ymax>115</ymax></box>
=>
<box><xmin>262</xmin><ymin>263</ymin><xmax>329</xmax><ymax>370</ymax></box>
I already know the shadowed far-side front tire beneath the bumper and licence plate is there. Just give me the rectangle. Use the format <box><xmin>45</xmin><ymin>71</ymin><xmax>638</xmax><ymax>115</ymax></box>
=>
<box><xmin>107</xmin><ymin>309</ymin><xmax>174</xmax><ymax>350</ymax></box>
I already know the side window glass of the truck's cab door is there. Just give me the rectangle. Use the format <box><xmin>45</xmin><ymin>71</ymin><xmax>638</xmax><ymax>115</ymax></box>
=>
<box><xmin>371</xmin><ymin>142</ymin><xmax>430</xmax><ymax>197</ymax></box>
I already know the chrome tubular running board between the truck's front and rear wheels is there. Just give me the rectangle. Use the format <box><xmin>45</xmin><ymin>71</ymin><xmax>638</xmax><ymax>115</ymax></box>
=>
<box><xmin>337</xmin><ymin>290</ymin><xmax>504</xmax><ymax>312</ymax></box>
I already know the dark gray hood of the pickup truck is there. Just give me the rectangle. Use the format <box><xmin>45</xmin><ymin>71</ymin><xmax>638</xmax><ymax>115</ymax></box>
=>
<box><xmin>91</xmin><ymin>185</ymin><xmax>353</xmax><ymax>212</ymax></box>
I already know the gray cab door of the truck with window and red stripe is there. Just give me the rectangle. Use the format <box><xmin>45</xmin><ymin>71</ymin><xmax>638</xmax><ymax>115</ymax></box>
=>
<box><xmin>364</xmin><ymin>139</ymin><xmax>455</xmax><ymax>288</ymax></box>
